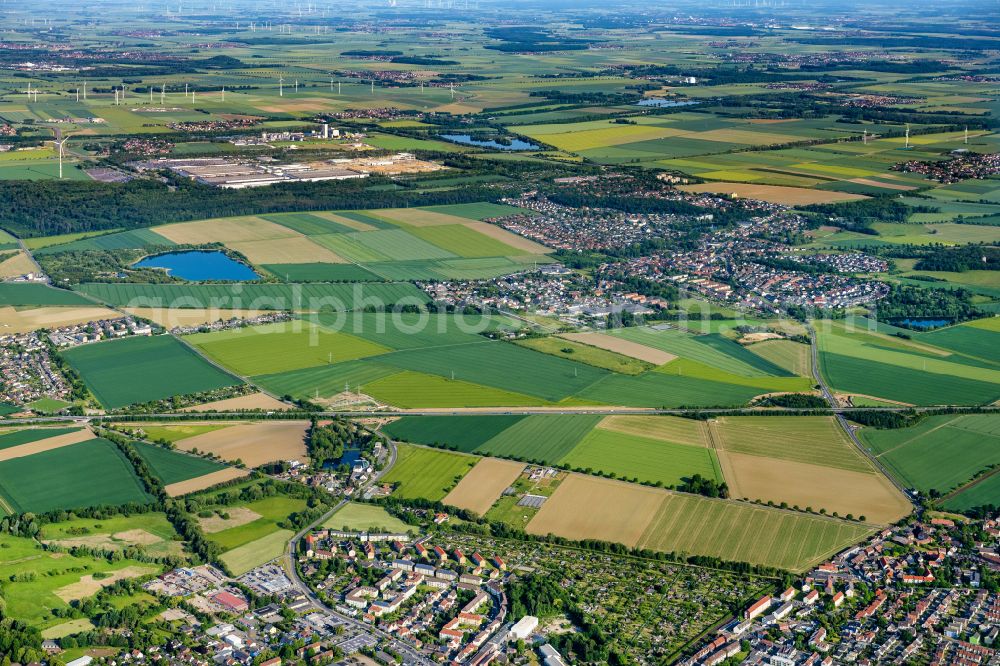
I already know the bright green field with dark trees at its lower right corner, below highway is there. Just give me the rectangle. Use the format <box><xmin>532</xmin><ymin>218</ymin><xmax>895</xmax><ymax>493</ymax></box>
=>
<box><xmin>559</xmin><ymin>428</ymin><xmax>724</xmax><ymax>486</ymax></box>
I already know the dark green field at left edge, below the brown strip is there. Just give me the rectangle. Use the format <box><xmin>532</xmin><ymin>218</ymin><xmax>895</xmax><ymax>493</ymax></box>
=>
<box><xmin>0</xmin><ymin>439</ymin><xmax>153</xmax><ymax>513</ymax></box>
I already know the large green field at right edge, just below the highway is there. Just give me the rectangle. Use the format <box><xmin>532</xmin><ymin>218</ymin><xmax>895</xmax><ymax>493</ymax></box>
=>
<box><xmin>860</xmin><ymin>414</ymin><xmax>1000</xmax><ymax>494</ymax></box>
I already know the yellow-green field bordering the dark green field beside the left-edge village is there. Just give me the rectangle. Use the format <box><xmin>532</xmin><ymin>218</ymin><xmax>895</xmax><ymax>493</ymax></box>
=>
<box><xmin>185</xmin><ymin>320</ymin><xmax>389</xmax><ymax>376</ymax></box>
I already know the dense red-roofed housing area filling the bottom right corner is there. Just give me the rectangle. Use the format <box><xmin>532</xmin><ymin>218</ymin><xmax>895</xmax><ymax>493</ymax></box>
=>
<box><xmin>683</xmin><ymin>517</ymin><xmax>1000</xmax><ymax>666</ymax></box>
